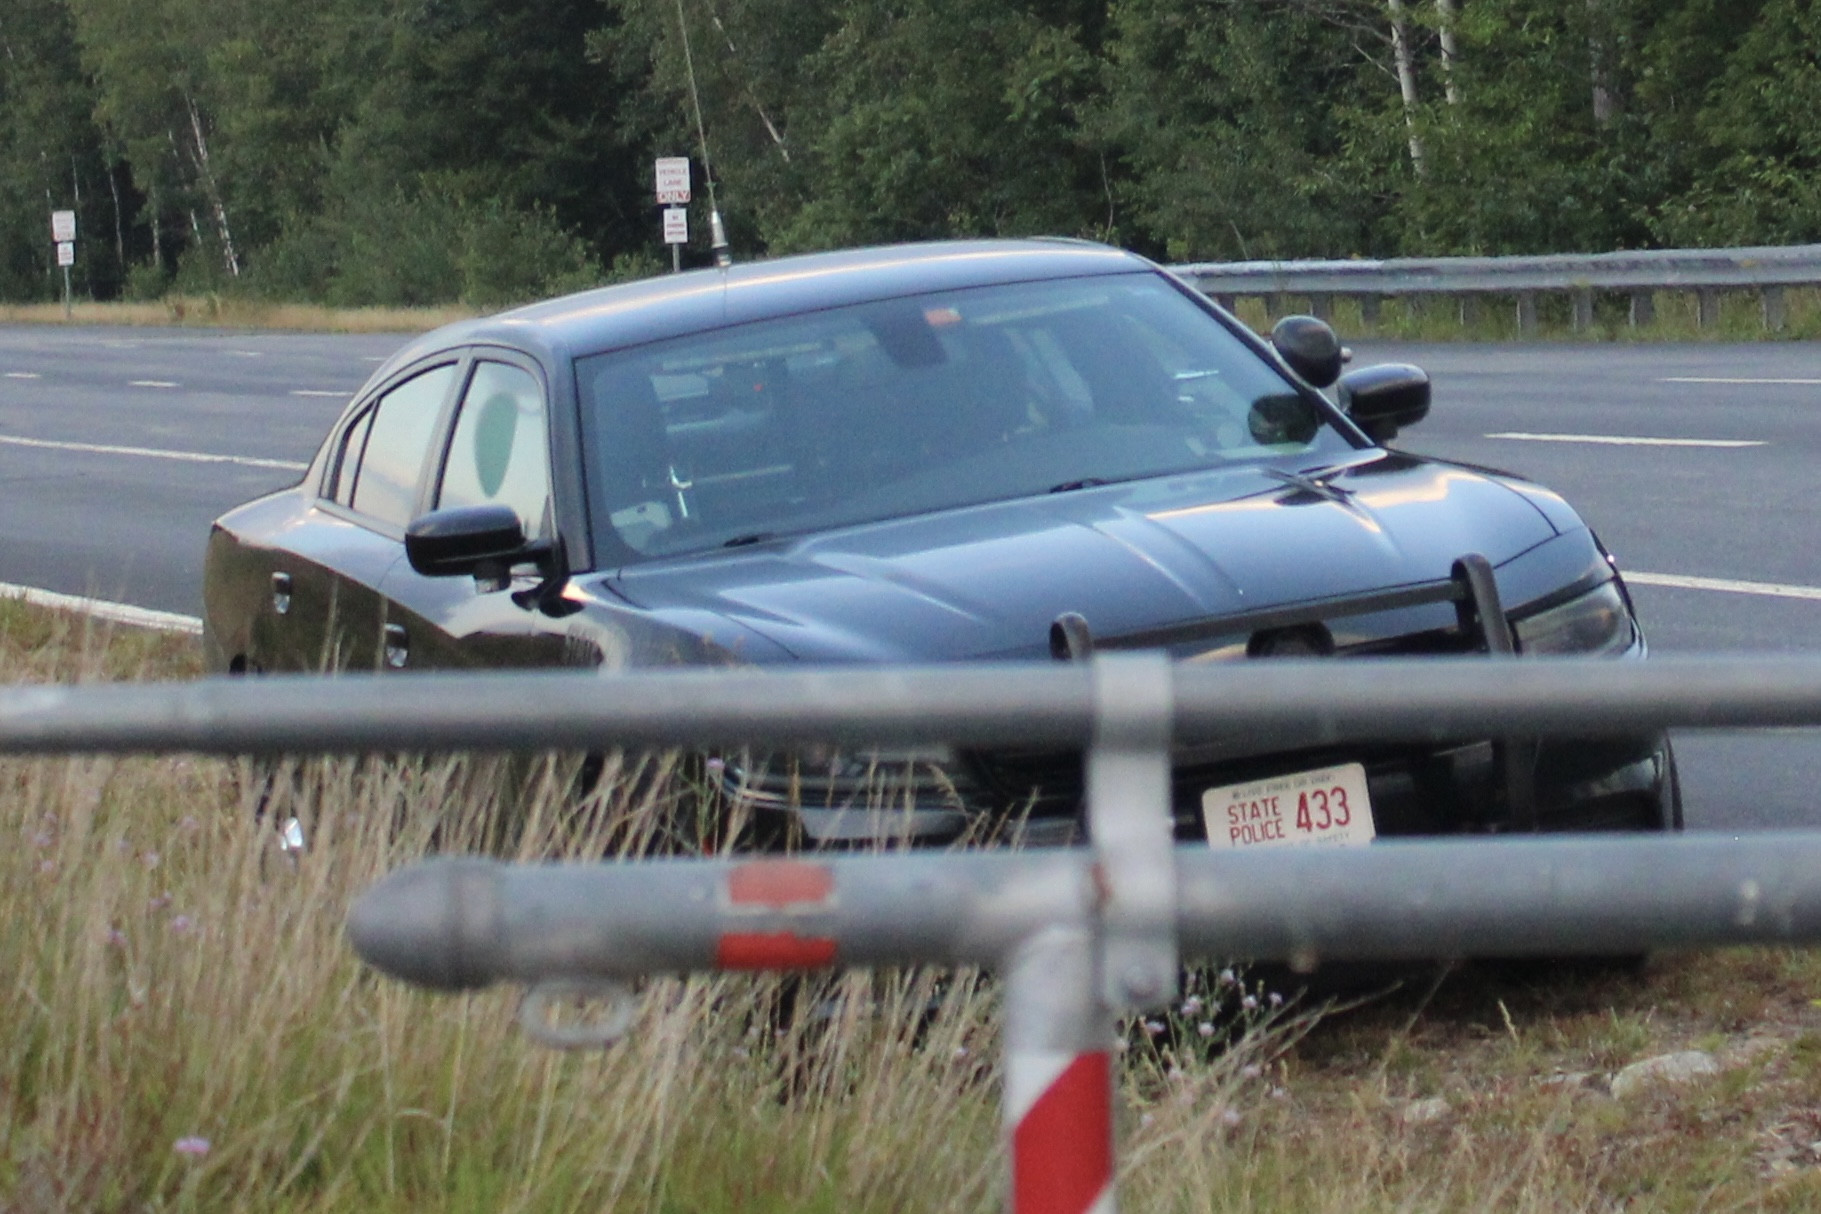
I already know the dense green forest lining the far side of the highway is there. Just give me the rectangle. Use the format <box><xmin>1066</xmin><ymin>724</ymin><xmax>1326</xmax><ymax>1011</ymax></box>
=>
<box><xmin>0</xmin><ymin>0</ymin><xmax>1821</xmax><ymax>306</ymax></box>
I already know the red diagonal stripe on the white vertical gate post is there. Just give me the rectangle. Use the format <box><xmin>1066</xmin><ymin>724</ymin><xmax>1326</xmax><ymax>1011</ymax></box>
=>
<box><xmin>1012</xmin><ymin>1050</ymin><xmax>1113</xmax><ymax>1214</ymax></box>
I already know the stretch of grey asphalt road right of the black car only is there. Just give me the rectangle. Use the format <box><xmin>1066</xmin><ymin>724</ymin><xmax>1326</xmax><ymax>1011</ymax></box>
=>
<box><xmin>1355</xmin><ymin>342</ymin><xmax>1821</xmax><ymax>830</ymax></box>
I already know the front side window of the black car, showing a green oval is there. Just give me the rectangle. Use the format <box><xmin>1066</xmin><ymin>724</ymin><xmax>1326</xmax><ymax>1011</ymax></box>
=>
<box><xmin>437</xmin><ymin>360</ymin><xmax>552</xmax><ymax>539</ymax></box>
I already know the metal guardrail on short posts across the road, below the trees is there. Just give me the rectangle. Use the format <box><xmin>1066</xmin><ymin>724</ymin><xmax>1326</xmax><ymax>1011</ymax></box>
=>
<box><xmin>1173</xmin><ymin>244</ymin><xmax>1821</xmax><ymax>333</ymax></box>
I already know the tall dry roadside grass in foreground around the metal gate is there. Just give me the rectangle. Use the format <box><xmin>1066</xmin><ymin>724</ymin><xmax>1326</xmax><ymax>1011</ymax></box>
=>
<box><xmin>0</xmin><ymin>604</ymin><xmax>1821</xmax><ymax>1214</ymax></box>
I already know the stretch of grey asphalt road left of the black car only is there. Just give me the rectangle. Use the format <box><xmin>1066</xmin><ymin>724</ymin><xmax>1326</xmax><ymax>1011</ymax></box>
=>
<box><xmin>0</xmin><ymin>326</ymin><xmax>406</xmax><ymax>615</ymax></box>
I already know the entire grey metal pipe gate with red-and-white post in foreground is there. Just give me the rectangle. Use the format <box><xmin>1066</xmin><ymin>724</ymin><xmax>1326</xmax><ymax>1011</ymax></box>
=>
<box><xmin>10</xmin><ymin>652</ymin><xmax>1821</xmax><ymax>1214</ymax></box>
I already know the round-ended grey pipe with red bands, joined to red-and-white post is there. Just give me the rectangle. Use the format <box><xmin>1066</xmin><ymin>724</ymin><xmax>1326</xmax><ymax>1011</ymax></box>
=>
<box><xmin>350</xmin><ymin>653</ymin><xmax>1176</xmax><ymax>1214</ymax></box>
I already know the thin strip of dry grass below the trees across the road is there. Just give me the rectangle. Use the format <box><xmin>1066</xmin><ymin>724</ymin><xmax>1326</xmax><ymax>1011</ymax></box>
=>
<box><xmin>0</xmin><ymin>295</ymin><xmax>481</xmax><ymax>333</ymax></box>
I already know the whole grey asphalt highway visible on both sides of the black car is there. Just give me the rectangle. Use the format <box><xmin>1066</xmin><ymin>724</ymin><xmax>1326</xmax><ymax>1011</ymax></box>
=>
<box><xmin>0</xmin><ymin>328</ymin><xmax>1821</xmax><ymax>830</ymax></box>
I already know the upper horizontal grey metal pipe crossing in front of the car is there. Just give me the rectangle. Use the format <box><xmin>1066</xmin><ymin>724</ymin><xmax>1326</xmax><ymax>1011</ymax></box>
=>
<box><xmin>14</xmin><ymin>653</ymin><xmax>1821</xmax><ymax>754</ymax></box>
